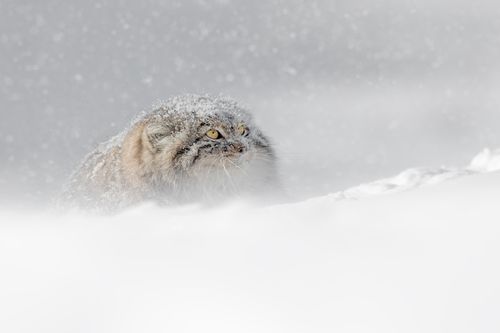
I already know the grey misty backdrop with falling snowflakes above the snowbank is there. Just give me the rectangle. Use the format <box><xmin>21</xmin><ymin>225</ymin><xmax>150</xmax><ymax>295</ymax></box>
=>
<box><xmin>0</xmin><ymin>0</ymin><xmax>500</xmax><ymax>205</ymax></box>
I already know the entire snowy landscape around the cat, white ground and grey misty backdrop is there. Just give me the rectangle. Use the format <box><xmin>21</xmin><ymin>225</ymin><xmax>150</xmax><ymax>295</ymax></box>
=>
<box><xmin>0</xmin><ymin>0</ymin><xmax>500</xmax><ymax>333</ymax></box>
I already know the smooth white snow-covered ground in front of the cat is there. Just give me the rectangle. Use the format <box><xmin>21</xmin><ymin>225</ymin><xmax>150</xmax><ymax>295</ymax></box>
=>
<box><xmin>0</xmin><ymin>150</ymin><xmax>500</xmax><ymax>333</ymax></box>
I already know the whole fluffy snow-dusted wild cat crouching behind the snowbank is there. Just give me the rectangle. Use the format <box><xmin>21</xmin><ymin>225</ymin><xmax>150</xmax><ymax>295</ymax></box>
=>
<box><xmin>63</xmin><ymin>95</ymin><xmax>278</xmax><ymax>211</ymax></box>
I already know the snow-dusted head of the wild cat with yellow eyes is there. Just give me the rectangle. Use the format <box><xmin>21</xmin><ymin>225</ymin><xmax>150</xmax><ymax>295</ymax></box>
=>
<box><xmin>145</xmin><ymin>96</ymin><xmax>275</xmax><ymax>198</ymax></box>
